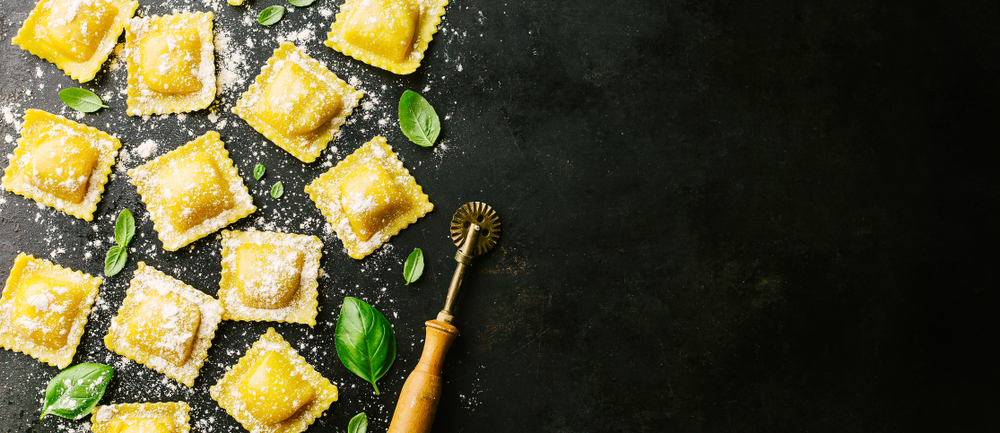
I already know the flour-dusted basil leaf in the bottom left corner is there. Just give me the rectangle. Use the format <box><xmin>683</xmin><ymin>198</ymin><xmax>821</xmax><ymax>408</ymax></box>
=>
<box><xmin>38</xmin><ymin>362</ymin><xmax>115</xmax><ymax>419</ymax></box>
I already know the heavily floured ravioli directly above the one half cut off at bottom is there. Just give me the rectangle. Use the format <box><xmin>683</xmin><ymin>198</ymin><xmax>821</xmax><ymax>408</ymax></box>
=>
<box><xmin>104</xmin><ymin>262</ymin><xmax>223</xmax><ymax>386</ymax></box>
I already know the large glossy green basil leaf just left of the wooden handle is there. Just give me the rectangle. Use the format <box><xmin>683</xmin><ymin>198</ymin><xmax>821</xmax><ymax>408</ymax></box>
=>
<box><xmin>336</xmin><ymin>297</ymin><xmax>396</xmax><ymax>395</ymax></box>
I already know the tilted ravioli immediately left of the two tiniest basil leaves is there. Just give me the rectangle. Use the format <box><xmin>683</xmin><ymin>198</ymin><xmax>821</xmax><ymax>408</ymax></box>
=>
<box><xmin>128</xmin><ymin>131</ymin><xmax>257</xmax><ymax>251</ymax></box>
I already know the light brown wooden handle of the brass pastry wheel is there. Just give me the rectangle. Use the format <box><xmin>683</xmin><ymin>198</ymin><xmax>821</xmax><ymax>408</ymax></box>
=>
<box><xmin>389</xmin><ymin>320</ymin><xmax>458</xmax><ymax>433</ymax></box>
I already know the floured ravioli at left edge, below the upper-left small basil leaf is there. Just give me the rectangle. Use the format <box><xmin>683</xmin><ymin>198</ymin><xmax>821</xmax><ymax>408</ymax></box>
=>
<box><xmin>3</xmin><ymin>110</ymin><xmax>122</xmax><ymax>221</ymax></box>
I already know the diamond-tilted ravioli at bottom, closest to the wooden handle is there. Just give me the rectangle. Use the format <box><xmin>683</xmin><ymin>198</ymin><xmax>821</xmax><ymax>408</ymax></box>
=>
<box><xmin>209</xmin><ymin>328</ymin><xmax>337</xmax><ymax>433</ymax></box>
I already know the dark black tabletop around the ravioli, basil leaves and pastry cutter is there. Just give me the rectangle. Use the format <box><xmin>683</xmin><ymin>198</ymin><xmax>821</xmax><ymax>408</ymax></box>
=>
<box><xmin>0</xmin><ymin>0</ymin><xmax>1000</xmax><ymax>432</ymax></box>
